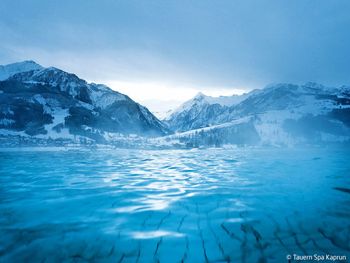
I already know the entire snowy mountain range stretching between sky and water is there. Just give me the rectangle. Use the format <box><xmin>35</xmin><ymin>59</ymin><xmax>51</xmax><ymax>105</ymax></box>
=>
<box><xmin>0</xmin><ymin>61</ymin><xmax>350</xmax><ymax>147</ymax></box>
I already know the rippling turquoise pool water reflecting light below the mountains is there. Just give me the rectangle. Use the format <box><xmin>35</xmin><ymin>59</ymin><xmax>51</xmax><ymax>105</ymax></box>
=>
<box><xmin>0</xmin><ymin>149</ymin><xmax>350</xmax><ymax>262</ymax></box>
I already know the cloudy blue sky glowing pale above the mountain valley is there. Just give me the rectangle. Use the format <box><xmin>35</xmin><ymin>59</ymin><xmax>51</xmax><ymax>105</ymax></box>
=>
<box><xmin>0</xmin><ymin>0</ymin><xmax>350</xmax><ymax>115</ymax></box>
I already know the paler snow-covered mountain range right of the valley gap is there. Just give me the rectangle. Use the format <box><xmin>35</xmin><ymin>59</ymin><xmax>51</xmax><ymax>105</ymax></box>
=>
<box><xmin>166</xmin><ymin>83</ymin><xmax>350</xmax><ymax>145</ymax></box>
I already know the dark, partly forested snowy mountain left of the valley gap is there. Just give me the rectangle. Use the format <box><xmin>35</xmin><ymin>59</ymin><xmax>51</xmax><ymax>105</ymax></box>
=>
<box><xmin>0</xmin><ymin>61</ymin><xmax>168</xmax><ymax>145</ymax></box>
